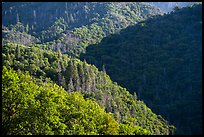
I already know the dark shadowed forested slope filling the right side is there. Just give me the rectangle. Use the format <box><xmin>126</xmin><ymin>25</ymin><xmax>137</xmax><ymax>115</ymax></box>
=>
<box><xmin>81</xmin><ymin>4</ymin><xmax>202</xmax><ymax>134</ymax></box>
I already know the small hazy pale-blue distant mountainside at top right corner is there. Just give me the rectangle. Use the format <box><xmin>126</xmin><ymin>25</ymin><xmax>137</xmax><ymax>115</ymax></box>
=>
<box><xmin>148</xmin><ymin>2</ymin><xmax>196</xmax><ymax>12</ymax></box>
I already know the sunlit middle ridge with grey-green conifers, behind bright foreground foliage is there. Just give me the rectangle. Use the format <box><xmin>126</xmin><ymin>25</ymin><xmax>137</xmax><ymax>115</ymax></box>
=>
<box><xmin>2</xmin><ymin>43</ymin><xmax>174</xmax><ymax>134</ymax></box>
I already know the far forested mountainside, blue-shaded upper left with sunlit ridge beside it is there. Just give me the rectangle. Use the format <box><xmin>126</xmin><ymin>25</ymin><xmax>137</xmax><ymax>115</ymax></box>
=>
<box><xmin>2</xmin><ymin>2</ymin><xmax>162</xmax><ymax>56</ymax></box>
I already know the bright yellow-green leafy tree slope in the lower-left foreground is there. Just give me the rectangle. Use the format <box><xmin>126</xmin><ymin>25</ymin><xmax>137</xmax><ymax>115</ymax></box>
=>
<box><xmin>2</xmin><ymin>66</ymin><xmax>150</xmax><ymax>135</ymax></box>
